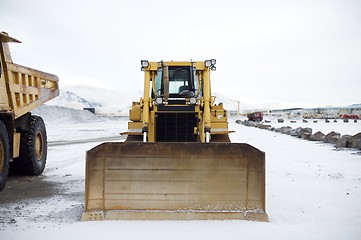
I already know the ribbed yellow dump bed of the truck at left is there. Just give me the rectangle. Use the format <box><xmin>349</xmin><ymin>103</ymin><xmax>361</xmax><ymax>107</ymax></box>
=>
<box><xmin>0</xmin><ymin>33</ymin><xmax>59</xmax><ymax>119</ymax></box>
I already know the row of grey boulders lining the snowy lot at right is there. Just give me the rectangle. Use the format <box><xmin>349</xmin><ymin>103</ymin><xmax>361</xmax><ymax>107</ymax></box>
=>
<box><xmin>236</xmin><ymin>120</ymin><xmax>361</xmax><ymax>150</ymax></box>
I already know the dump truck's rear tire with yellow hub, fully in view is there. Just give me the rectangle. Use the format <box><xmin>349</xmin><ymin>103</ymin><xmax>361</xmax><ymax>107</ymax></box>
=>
<box><xmin>14</xmin><ymin>116</ymin><xmax>48</xmax><ymax>176</ymax></box>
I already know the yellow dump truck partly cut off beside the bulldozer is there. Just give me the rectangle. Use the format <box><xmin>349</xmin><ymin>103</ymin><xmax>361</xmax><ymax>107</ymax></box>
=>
<box><xmin>0</xmin><ymin>32</ymin><xmax>59</xmax><ymax>190</ymax></box>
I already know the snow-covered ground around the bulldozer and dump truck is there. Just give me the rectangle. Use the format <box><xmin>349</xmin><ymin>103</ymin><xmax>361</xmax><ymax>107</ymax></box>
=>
<box><xmin>0</xmin><ymin>107</ymin><xmax>361</xmax><ymax>240</ymax></box>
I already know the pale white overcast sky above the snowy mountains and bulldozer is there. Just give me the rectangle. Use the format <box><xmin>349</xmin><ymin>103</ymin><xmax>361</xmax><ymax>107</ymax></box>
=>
<box><xmin>0</xmin><ymin>0</ymin><xmax>361</xmax><ymax>107</ymax></box>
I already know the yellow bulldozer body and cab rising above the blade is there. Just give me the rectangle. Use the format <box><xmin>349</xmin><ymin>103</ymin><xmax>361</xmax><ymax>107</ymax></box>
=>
<box><xmin>135</xmin><ymin>59</ymin><xmax>221</xmax><ymax>142</ymax></box>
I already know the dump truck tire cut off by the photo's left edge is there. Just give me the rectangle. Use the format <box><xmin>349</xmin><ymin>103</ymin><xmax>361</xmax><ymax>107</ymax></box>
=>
<box><xmin>0</xmin><ymin>121</ymin><xmax>10</xmax><ymax>191</ymax></box>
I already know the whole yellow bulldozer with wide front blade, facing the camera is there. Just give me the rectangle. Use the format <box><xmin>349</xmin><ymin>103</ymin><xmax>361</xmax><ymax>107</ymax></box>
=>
<box><xmin>82</xmin><ymin>59</ymin><xmax>268</xmax><ymax>221</ymax></box>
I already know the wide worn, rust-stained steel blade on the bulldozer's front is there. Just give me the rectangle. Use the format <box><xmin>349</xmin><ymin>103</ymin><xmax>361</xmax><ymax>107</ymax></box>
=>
<box><xmin>82</xmin><ymin>142</ymin><xmax>268</xmax><ymax>221</ymax></box>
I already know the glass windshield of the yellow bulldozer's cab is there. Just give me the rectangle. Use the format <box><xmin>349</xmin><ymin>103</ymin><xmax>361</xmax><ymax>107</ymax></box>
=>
<box><xmin>155</xmin><ymin>66</ymin><xmax>198</xmax><ymax>97</ymax></box>
